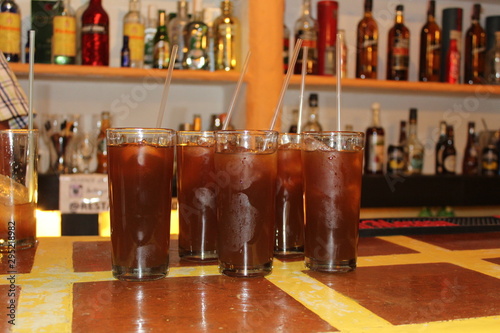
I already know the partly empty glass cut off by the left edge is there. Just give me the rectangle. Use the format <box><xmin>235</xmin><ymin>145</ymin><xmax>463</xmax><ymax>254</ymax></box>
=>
<box><xmin>0</xmin><ymin>130</ymin><xmax>38</xmax><ymax>250</ymax></box>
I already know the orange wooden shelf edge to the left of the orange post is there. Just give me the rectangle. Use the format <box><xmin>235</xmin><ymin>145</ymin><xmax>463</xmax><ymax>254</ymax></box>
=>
<box><xmin>10</xmin><ymin>63</ymin><xmax>240</xmax><ymax>83</ymax></box>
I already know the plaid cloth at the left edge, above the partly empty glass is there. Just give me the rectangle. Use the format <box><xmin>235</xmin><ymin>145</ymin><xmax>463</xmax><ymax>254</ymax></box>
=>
<box><xmin>0</xmin><ymin>51</ymin><xmax>28</xmax><ymax>128</ymax></box>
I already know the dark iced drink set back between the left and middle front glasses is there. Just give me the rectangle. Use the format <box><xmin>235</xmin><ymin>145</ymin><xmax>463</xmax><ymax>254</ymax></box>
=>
<box><xmin>177</xmin><ymin>131</ymin><xmax>217</xmax><ymax>261</ymax></box>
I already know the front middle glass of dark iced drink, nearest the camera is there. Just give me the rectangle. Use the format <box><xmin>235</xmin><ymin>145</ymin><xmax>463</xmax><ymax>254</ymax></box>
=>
<box><xmin>215</xmin><ymin>131</ymin><xmax>278</xmax><ymax>277</ymax></box>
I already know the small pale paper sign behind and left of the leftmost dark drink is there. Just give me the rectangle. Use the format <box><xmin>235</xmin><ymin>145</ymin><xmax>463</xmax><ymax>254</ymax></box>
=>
<box><xmin>59</xmin><ymin>174</ymin><xmax>109</xmax><ymax>214</ymax></box>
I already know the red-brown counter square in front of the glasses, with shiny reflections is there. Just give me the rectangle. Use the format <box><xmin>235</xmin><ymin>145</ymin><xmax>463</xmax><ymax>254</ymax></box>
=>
<box><xmin>73</xmin><ymin>276</ymin><xmax>335</xmax><ymax>333</ymax></box>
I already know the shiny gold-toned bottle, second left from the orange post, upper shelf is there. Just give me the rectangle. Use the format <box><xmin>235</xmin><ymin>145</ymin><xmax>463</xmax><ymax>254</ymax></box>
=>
<box><xmin>182</xmin><ymin>0</ymin><xmax>209</xmax><ymax>70</ymax></box>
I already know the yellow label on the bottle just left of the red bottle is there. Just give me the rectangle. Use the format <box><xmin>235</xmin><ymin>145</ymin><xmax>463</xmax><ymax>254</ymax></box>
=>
<box><xmin>52</xmin><ymin>16</ymin><xmax>76</xmax><ymax>57</ymax></box>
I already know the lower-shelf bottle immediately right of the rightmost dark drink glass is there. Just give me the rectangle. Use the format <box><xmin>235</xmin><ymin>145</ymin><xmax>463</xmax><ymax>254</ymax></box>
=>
<box><xmin>365</xmin><ymin>103</ymin><xmax>385</xmax><ymax>174</ymax></box>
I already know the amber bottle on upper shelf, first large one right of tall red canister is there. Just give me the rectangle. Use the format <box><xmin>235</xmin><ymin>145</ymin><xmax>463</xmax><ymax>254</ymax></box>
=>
<box><xmin>356</xmin><ymin>0</ymin><xmax>378</xmax><ymax>79</ymax></box>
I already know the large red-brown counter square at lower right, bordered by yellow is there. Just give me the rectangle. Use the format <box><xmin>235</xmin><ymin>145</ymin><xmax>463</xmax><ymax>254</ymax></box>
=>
<box><xmin>305</xmin><ymin>263</ymin><xmax>500</xmax><ymax>325</ymax></box>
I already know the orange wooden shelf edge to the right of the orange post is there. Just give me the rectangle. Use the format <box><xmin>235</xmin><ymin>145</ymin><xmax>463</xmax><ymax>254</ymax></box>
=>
<box><xmin>290</xmin><ymin>75</ymin><xmax>500</xmax><ymax>97</ymax></box>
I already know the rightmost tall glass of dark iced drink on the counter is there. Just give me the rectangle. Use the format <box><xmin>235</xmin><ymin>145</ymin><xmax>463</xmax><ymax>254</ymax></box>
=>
<box><xmin>302</xmin><ymin>132</ymin><xmax>364</xmax><ymax>272</ymax></box>
